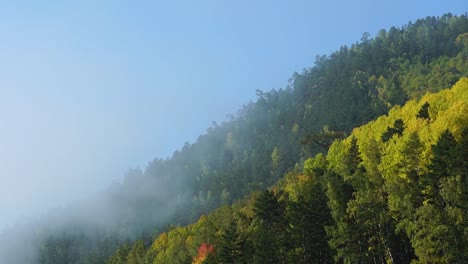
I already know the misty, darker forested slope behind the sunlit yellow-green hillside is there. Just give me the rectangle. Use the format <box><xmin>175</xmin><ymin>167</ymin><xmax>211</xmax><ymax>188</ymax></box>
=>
<box><xmin>0</xmin><ymin>14</ymin><xmax>468</xmax><ymax>263</ymax></box>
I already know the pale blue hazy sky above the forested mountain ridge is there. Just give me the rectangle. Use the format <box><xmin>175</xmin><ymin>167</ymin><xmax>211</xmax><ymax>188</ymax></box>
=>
<box><xmin>0</xmin><ymin>0</ymin><xmax>467</xmax><ymax>228</ymax></box>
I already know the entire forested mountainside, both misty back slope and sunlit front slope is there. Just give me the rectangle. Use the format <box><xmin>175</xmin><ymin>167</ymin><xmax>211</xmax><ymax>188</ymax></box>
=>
<box><xmin>0</xmin><ymin>14</ymin><xmax>468</xmax><ymax>263</ymax></box>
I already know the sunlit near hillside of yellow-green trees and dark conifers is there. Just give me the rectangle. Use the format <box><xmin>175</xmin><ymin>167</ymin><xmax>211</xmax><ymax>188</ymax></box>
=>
<box><xmin>107</xmin><ymin>78</ymin><xmax>468</xmax><ymax>264</ymax></box>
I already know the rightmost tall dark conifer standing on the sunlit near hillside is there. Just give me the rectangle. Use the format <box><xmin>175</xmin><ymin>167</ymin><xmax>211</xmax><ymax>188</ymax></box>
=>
<box><xmin>411</xmin><ymin>129</ymin><xmax>466</xmax><ymax>263</ymax></box>
